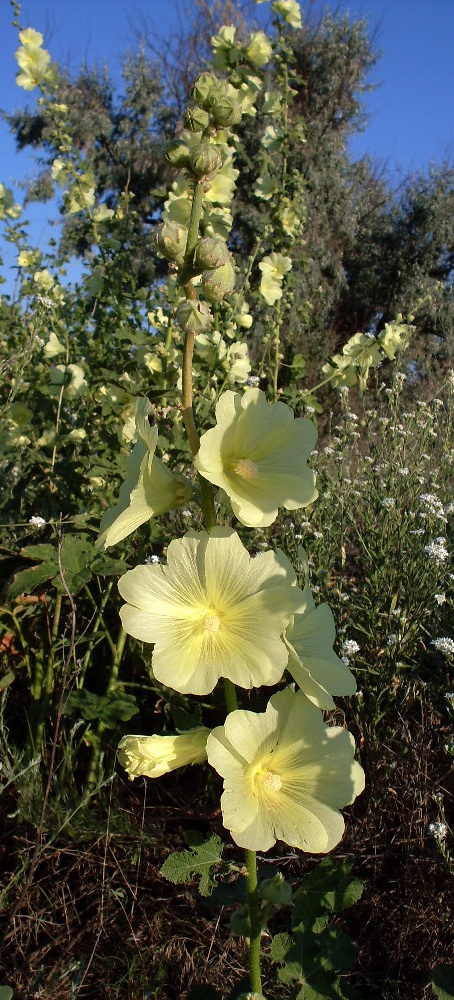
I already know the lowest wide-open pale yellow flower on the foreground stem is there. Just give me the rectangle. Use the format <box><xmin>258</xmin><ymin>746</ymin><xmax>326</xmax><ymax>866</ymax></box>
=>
<box><xmin>207</xmin><ymin>688</ymin><xmax>364</xmax><ymax>854</ymax></box>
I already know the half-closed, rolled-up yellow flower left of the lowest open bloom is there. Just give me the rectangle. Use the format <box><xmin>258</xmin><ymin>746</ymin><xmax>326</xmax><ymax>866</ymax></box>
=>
<box><xmin>118</xmin><ymin>726</ymin><xmax>210</xmax><ymax>780</ymax></box>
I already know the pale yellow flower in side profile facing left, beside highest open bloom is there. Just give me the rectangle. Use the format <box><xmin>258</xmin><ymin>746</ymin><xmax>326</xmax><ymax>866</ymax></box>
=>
<box><xmin>96</xmin><ymin>397</ymin><xmax>192</xmax><ymax>548</ymax></box>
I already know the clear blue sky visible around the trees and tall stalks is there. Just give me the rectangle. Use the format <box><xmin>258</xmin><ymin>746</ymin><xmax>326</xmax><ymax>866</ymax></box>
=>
<box><xmin>0</xmin><ymin>0</ymin><xmax>454</xmax><ymax>290</ymax></box>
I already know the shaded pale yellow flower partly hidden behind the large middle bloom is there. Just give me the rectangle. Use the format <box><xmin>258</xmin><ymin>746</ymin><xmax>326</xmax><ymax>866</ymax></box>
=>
<box><xmin>284</xmin><ymin>586</ymin><xmax>356</xmax><ymax>709</ymax></box>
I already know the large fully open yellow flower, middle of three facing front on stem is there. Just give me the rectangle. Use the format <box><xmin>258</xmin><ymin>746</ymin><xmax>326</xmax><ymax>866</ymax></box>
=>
<box><xmin>118</xmin><ymin>527</ymin><xmax>303</xmax><ymax>695</ymax></box>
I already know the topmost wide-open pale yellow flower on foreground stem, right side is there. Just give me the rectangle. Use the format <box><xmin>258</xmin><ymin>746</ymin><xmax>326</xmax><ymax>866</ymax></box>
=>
<box><xmin>194</xmin><ymin>389</ymin><xmax>318</xmax><ymax>528</ymax></box>
